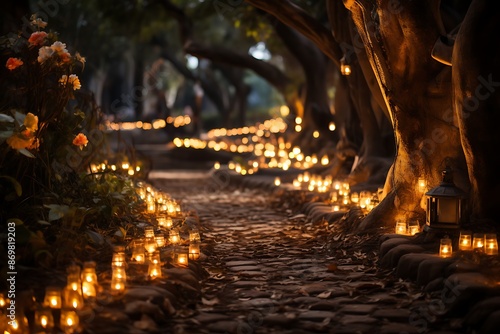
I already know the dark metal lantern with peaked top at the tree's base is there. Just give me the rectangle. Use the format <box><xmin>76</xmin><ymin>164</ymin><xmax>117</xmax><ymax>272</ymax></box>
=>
<box><xmin>425</xmin><ymin>167</ymin><xmax>466</xmax><ymax>230</ymax></box>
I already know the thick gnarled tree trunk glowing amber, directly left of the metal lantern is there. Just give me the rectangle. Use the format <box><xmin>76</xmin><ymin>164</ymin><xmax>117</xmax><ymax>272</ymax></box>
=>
<box><xmin>344</xmin><ymin>0</ymin><xmax>468</xmax><ymax>228</ymax></box>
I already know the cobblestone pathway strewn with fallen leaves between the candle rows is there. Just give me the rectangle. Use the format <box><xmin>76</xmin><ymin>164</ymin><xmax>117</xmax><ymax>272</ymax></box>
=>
<box><xmin>151</xmin><ymin>174</ymin><xmax>427</xmax><ymax>334</ymax></box>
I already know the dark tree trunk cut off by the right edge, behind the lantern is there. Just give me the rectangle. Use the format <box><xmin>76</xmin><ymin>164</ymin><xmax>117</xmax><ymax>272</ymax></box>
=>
<box><xmin>452</xmin><ymin>0</ymin><xmax>500</xmax><ymax>222</ymax></box>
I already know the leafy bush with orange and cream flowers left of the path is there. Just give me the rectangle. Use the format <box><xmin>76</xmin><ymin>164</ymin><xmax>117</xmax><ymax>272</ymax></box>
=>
<box><xmin>0</xmin><ymin>16</ymin><xmax>150</xmax><ymax>266</ymax></box>
